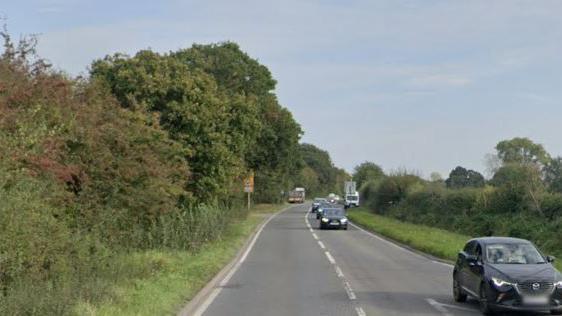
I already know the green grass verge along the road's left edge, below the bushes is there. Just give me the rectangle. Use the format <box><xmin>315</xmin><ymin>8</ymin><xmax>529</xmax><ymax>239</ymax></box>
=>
<box><xmin>75</xmin><ymin>204</ymin><xmax>284</xmax><ymax>315</ymax></box>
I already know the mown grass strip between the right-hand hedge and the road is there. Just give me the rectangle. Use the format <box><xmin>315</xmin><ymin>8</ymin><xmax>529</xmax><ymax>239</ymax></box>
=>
<box><xmin>347</xmin><ymin>208</ymin><xmax>562</xmax><ymax>270</ymax></box>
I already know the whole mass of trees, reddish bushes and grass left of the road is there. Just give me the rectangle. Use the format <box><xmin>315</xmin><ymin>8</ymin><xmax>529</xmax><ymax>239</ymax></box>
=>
<box><xmin>0</xmin><ymin>31</ymin><xmax>333</xmax><ymax>315</ymax></box>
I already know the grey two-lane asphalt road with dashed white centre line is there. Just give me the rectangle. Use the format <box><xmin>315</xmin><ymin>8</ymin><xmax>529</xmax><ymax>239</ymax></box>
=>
<box><xmin>200</xmin><ymin>205</ymin><xmax>486</xmax><ymax>316</ymax></box>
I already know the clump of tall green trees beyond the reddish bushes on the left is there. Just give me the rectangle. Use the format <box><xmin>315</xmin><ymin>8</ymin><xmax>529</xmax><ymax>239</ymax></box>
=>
<box><xmin>91</xmin><ymin>42</ymin><xmax>302</xmax><ymax>202</ymax></box>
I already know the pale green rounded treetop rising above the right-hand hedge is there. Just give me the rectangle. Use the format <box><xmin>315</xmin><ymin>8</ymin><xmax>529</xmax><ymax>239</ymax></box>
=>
<box><xmin>496</xmin><ymin>137</ymin><xmax>550</xmax><ymax>165</ymax></box>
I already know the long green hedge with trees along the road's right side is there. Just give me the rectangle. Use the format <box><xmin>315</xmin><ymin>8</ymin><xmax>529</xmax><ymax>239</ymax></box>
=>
<box><xmin>352</xmin><ymin>138</ymin><xmax>562</xmax><ymax>267</ymax></box>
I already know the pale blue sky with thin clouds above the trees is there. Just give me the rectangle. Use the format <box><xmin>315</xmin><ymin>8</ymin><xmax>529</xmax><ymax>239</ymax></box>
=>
<box><xmin>0</xmin><ymin>0</ymin><xmax>562</xmax><ymax>177</ymax></box>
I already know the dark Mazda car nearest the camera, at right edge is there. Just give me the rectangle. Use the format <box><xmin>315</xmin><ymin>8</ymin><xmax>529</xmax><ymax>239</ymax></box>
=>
<box><xmin>453</xmin><ymin>237</ymin><xmax>562</xmax><ymax>315</ymax></box>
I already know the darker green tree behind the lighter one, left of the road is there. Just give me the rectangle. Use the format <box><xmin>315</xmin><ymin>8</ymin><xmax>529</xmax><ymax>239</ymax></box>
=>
<box><xmin>171</xmin><ymin>42</ymin><xmax>302</xmax><ymax>201</ymax></box>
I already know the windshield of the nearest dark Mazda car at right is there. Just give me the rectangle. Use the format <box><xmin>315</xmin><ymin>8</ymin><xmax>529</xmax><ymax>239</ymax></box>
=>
<box><xmin>486</xmin><ymin>243</ymin><xmax>545</xmax><ymax>264</ymax></box>
